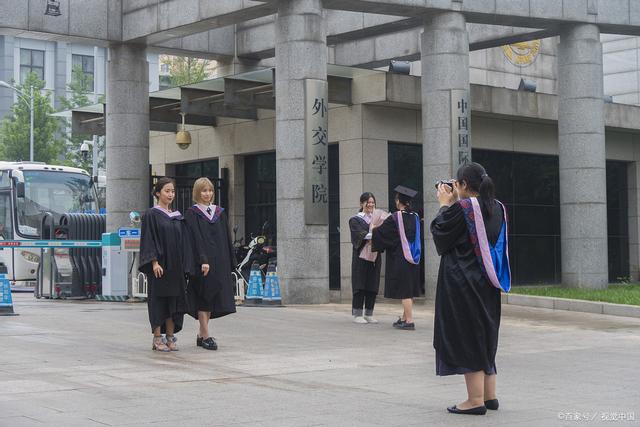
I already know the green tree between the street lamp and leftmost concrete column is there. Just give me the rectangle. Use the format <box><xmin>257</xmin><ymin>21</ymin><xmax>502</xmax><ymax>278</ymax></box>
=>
<box><xmin>58</xmin><ymin>66</ymin><xmax>105</xmax><ymax>173</ymax></box>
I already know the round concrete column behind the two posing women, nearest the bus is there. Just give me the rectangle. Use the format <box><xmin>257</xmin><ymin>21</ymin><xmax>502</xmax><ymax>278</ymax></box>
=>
<box><xmin>106</xmin><ymin>44</ymin><xmax>150</xmax><ymax>232</ymax></box>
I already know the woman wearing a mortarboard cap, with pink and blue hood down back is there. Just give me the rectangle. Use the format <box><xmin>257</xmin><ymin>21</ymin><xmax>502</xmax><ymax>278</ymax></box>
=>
<box><xmin>371</xmin><ymin>185</ymin><xmax>421</xmax><ymax>330</ymax></box>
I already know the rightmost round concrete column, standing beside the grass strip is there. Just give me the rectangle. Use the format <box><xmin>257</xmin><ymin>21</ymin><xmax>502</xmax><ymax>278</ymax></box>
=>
<box><xmin>558</xmin><ymin>24</ymin><xmax>608</xmax><ymax>288</ymax></box>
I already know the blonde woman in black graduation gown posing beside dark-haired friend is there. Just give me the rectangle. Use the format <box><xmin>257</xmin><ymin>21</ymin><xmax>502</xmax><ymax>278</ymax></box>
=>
<box><xmin>185</xmin><ymin>178</ymin><xmax>236</xmax><ymax>350</ymax></box>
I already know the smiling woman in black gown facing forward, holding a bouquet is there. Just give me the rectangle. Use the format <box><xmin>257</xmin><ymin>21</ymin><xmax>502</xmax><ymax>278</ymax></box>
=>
<box><xmin>349</xmin><ymin>193</ymin><xmax>381</xmax><ymax>323</ymax></box>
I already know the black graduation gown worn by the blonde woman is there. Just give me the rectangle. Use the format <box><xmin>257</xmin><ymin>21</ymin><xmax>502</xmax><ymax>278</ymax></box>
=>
<box><xmin>185</xmin><ymin>206</ymin><xmax>236</xmax><ymax>319</ymax></box>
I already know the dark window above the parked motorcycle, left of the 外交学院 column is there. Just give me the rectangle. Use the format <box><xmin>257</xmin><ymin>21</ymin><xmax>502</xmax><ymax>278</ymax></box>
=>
<box><xmin>244</xmin><ymin>153</ymin><xmax>277</xmax><ymax>245</ymax></box>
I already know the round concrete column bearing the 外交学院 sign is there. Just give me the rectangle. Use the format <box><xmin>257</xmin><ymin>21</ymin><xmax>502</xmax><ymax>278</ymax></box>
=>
<box><xmin>276</xmin><ymin>0</ymin><xmax>329</xmax><ymax>304</ymax></box>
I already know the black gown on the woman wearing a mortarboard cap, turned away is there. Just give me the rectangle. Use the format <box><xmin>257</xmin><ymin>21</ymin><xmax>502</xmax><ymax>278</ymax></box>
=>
<box><xmin>371</xmin><ymin>212</ymin><xmax>421</xmax><ymax>299</ymax></box>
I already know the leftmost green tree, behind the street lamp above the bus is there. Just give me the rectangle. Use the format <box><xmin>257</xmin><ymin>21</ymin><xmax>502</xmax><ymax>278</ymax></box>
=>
<box><xmin>0</xmin><ymin>73</ymin><xmax>64</xmax><ymax>163</ymax></box>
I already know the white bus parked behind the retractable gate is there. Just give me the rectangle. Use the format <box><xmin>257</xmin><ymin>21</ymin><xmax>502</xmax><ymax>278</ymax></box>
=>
<box><xmin>0</xmin><ymin>161</ymin><xmax>99</xmax><ymax>289</ymax></box>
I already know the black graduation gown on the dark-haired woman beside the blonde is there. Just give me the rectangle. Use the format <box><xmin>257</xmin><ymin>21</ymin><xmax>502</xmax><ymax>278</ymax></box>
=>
<box><xmin>138</xmin><ymin>208</ymin><xmax>193</xmax><ymax>333</ymax></box>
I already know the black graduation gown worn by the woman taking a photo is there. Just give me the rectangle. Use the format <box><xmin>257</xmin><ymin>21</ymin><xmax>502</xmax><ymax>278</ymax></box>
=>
<box><xmin>431</xmin><ymin>203</ymin><xmax>504</xmax><ymax>375</ymax></box>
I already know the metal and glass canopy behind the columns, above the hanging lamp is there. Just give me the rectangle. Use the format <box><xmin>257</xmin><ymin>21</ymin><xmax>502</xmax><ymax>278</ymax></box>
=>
<box><xmin>67</xmin><ymin>64</ymin><xmax>372</xmax><ymax>135</ymax></box>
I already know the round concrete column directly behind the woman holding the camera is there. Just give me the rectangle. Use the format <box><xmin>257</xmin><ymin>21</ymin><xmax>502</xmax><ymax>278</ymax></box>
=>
<box><xmin>421</xmin><ymin>12</ymin><xmax>471</xmax><ymax>298</ymax></box>
